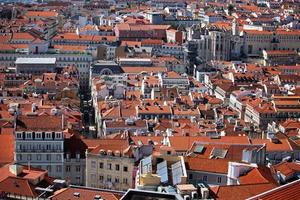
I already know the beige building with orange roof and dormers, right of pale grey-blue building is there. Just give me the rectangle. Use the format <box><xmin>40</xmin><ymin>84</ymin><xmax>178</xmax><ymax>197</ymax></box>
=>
<box><xmin>86</xmin><ymin>139</ymin><xmax>152</xmax><ymax>191</ymax></box>
